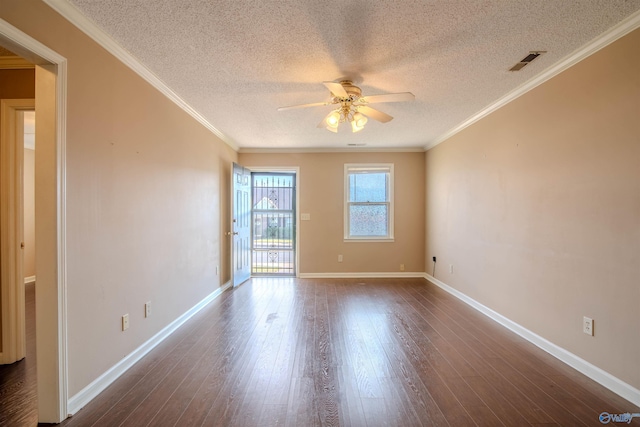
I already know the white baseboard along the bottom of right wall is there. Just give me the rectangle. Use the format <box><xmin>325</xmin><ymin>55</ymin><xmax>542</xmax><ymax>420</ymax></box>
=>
<box><xmin>423</xmin><ymin>273</ymin><xmax>640</xmax><ymax>406</ymax></box>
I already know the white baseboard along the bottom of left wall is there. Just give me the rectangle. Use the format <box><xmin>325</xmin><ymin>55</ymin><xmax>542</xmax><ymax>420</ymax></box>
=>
<box><xmin>67</xmin><ymin>282</ymin><xmax>231</xmax><ymax>415</ymax></box>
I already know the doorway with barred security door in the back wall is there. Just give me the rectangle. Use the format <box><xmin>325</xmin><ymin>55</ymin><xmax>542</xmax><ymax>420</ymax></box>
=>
<box><xmin>251</xmin><ymin>172</ymin><xmax>297</xmax><ymax>276</ymax></box>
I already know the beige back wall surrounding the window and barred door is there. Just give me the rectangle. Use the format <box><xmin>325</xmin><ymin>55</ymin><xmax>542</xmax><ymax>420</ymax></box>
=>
<box><xmin>239</xmin><ymin>152</ymin><xmax>424</xmax><ymax>274</ymax></box>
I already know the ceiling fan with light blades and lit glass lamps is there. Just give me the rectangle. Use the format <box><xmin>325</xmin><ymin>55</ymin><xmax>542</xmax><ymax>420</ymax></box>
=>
<box><xmin>278</xmin><ymin>80</ymin><xmax>416</xmax><ymax>133</ymax></box>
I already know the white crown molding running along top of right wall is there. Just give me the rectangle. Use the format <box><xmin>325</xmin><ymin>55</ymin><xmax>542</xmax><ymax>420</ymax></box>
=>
<box><xmin>424</xmin><ymin>7</ymin><xmax>640</xmax><ymax>151</ymax></box>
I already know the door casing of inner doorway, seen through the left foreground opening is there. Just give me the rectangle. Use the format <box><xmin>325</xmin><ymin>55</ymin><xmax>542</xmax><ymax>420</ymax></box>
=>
<box><xmin>0</xmin><ymin>99</ymin><xmax>35</xmax><ymax>364</ymax></box>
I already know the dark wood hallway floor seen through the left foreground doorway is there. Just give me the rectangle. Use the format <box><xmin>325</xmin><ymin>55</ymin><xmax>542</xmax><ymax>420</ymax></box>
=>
<box><xmin>0</xmin><ymin>283</ymin><xmax>38</xmax><ymax>427</ymax></box>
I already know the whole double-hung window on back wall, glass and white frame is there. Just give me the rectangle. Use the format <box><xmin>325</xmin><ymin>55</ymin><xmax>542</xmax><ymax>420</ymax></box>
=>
<box><xmin>344</xmin><ymin>163</ymin><xmax>393</xmax><ymax>242</ymax></box>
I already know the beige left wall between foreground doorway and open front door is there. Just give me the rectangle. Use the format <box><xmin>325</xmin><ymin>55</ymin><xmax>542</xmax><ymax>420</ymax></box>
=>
<box><xmin>0</xmin><ymin>0</ymin><xmax>237</xmax><ymax>396</ymax></box>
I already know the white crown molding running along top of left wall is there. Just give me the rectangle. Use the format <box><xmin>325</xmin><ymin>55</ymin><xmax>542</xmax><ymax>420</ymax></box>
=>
<box><xmin>43</xmin><ymin>0</ymin><xmax>238</xmax><ymax>151</ymax></box>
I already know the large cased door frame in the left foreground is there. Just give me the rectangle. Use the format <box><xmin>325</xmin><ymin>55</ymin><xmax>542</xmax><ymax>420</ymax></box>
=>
<box><xmin>0</xmin><ymin>19</ymin><xmax>68</xmax><ymax>423</ymax></box>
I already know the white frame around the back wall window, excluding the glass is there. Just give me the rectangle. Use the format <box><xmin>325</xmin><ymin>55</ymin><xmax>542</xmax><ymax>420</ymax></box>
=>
<box><xmin>344</xmin><ymin>163</ymin><xmax>394</xmax><ymax>242</ymax></box>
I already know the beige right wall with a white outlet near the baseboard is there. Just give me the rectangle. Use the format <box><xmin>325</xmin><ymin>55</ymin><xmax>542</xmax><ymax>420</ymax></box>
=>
<box><xmin>425</xmin><ymin>30</ymin><xmax>640</xmax><ymax>388</ymax></box>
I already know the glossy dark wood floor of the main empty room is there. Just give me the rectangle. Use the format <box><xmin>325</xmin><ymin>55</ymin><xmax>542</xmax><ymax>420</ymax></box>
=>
<box><xmin>0</xmin><ymin>278</ymin><xmax>640</xmax><ymax>427</ymax></box>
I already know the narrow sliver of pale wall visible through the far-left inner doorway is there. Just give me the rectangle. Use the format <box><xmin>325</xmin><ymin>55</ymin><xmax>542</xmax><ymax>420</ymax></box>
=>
<box><xmin>23</xmin><ymin>148</ymin><xmax>36</xmax><ymax>278</ymax></box>
